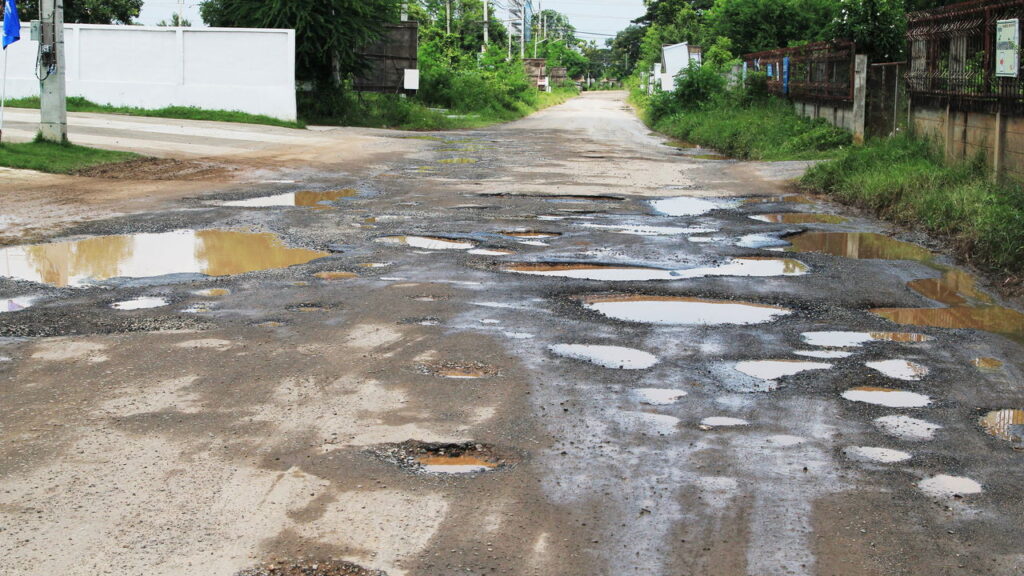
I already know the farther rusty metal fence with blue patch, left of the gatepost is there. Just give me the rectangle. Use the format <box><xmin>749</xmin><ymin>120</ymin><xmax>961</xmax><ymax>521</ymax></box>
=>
<box><xmin>743</xmin><ymin>40</ymin><xmax>856</xmax><ymax>102</ymax></box>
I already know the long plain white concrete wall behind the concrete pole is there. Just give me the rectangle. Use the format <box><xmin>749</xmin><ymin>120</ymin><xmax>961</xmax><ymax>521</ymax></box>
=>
<box><xmin>7</xmin><ymin>22</ymin><xmax>296</xmax><ymax>120</ymax></box>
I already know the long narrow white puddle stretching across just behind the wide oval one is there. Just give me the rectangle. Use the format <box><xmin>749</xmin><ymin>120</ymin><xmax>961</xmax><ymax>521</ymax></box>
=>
<box><xmin>504</xmin><ymin>257</ymin><xmax>808</xmax><ymax>282</ymax></box>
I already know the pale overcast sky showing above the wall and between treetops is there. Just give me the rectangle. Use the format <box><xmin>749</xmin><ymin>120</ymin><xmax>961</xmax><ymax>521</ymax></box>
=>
<box><xmin>138</xmin><ymin>0</ymin><xmax>644</xmax><ymax>39</ymax></box>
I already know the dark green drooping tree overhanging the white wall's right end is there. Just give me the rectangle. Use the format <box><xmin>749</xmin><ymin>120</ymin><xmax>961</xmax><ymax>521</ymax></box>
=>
<box><xmin>200</xmin><ymin>0</ymin><xmax>400</xmax><ymax>85</ymax></box>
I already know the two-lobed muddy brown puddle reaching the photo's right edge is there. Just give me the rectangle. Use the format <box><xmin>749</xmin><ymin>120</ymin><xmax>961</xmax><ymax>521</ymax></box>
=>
<box><xmin>871</xmin><ymin>270</ymin><xmax>1024</xmax><ymax>340</ymax></box>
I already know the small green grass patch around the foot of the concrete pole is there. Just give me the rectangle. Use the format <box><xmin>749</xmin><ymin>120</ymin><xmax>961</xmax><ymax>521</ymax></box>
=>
<box><xmin>0</xmin><ymin>139</ymin><xmax>141</xmax><ymax>174</ymax></box>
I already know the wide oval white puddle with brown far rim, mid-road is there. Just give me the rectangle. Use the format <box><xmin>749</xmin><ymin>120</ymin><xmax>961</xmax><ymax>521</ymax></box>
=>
<box><xmin>583</xmin><ymin>295</ymin><xmax>791</xmax><ymax>326</ymax></box>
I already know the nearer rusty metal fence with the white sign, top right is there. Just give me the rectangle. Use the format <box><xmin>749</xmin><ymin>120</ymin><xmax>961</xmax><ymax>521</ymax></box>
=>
<box><xmin>906</xmin><ymin>0</ymin><xmax>1024</xmax><ymax>114</ymax></box>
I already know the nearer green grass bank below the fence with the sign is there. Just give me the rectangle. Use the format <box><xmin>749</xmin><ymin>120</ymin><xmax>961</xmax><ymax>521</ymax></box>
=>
<box><xmin>800</xmin><ymin>135</ymin><xmax>1024</xmax><ymax>276</ymax></box>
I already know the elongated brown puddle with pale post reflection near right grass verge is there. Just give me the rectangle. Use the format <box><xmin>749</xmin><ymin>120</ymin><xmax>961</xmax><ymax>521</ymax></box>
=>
<box><xmin>786</xmin><ymin>232</ymin><xmax>932</xmax><ymax>262</ymax></box>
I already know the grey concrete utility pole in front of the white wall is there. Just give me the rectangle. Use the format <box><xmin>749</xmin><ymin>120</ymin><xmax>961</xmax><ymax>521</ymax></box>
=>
<box><xmin>37</xmin><ymin>0</ymin><xmax>68</xmax><ymax>142</ymax></box>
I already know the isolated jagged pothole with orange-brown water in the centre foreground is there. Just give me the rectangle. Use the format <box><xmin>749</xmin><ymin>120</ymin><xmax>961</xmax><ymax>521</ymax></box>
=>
<box><xmin>373</xmin><ymin>440</ymin><xmax>507</xmax><ymax>475</ymax></box>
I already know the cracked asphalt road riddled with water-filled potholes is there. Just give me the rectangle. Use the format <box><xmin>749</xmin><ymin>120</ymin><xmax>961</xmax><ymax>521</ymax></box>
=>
<box><xmin>0</xmin><ymin>93</ymin><xmax>1024</xmax><ymax>576</ymax></box>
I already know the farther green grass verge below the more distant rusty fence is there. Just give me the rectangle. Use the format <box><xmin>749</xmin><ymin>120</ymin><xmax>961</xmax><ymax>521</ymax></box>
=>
<box><xmin>641</xmin><ymin>98</ymin><xmax>852</xmax><ymax>160</ymax></box>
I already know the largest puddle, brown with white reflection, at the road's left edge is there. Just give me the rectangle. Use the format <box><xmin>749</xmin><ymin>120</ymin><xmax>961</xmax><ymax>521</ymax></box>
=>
<box><xmin>0</xmin><ymin>230</ymin><xmax>330</xmax><ymax>287</ymax></box>
